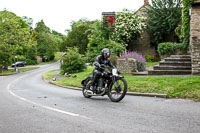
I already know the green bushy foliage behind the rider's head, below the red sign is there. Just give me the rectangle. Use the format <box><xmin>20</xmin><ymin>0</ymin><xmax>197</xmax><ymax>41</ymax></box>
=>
<box><xmin>86</xmin><ymin>21</ymin><xmax>125</xmax><ymax>62</ymax></box>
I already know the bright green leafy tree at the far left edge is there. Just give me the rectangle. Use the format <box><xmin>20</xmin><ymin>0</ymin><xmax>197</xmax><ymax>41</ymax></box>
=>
<box><xmin>0</xmin><ymin>10</ymin><xmax>30</xmax><ymax>72</ymax></box>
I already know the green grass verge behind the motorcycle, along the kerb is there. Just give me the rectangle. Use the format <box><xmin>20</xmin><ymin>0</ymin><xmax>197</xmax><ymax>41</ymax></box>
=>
<box><xmin>44</xmin><ymin>67</ymin><xmax>200</xmax><ymax>101</ymax></box>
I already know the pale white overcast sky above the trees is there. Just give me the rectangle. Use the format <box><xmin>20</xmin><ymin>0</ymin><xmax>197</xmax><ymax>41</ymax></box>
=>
<box><xmin>0</xmin><ymin>0</ymin><xmax>144</xmax><ymax>34</ymax></box>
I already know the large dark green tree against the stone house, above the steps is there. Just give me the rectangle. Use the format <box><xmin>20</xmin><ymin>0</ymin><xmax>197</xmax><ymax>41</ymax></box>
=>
<box><xmin>146</xmin><ymin>0</ymin><xmax>181</xmax><ymax>45</ymax></box>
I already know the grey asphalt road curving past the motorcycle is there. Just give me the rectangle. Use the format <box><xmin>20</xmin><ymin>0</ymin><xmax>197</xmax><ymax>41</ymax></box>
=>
<box><xmin>0</xmin><ymin>63</ymin><xmax>200</xmax><ymax>133</ymax></box>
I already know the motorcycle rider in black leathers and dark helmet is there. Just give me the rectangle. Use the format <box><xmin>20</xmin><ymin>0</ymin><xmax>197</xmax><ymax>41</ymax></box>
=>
<box><xmin>90</xmin><ymin>48</ymin><xmax>115</xmax><ymax>92</ymax></box>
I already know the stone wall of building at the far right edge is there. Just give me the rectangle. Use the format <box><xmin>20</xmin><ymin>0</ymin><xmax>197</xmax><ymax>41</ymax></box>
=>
<box><xmin>190</xmin><ymin>0</ymin><xmax>200</xmax><ymax>75</ymax></box>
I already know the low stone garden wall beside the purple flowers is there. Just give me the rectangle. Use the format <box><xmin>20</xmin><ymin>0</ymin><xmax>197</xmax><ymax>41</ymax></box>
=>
<box><xmin>117</xmin><ymin>58</ymin><xmax>137</xmax><ymax>74</ymax></box>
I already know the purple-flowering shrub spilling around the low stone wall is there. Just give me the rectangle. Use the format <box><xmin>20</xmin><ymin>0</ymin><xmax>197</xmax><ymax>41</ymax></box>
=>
<box><xmin>120</xmin><ymin>51</ymin><xmax>146</xmax><ymax>71</ymax></box>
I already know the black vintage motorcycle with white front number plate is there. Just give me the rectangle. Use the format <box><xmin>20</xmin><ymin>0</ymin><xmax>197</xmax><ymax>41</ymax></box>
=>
<box><xmin>81</xmin><ymin>67</ymin><xmax>127</xmax><ymax>102</ymax></box>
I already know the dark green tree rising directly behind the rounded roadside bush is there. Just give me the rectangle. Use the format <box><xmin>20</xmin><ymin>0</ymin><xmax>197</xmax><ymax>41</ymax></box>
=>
<box><xmin>64</xmin><ymin>19</ymin><xmax>91</xmax><ymax>54</ymax></box>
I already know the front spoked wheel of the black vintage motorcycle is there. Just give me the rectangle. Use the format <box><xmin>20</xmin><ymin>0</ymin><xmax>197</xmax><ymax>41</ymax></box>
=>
<box><xmin>108</xmin><ymin>78</ymin><xmax>127</xmax><ymax>102</ymax></box>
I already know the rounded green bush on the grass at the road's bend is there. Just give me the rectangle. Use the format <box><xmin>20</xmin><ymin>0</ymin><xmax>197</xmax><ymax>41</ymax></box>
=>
<box><xmin>61</xmin><ymin>48</ymin><xmax>86</xmax><ymax>74</ymax></box>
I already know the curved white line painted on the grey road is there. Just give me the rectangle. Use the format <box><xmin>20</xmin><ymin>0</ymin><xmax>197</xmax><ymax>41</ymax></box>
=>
<box><xmin>7</xmin><ymin>66</ymin><xmax>91</xmax><ymax>119</ymax></box>
